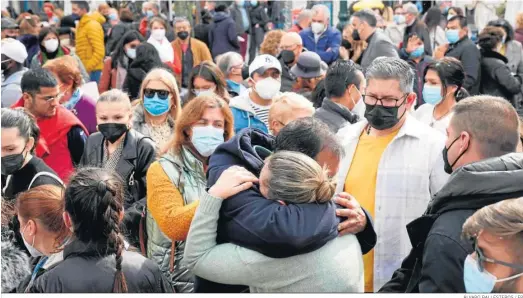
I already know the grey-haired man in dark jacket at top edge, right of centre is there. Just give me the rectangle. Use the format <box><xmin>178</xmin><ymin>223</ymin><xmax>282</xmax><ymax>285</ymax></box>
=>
<box><xmin>400</xmin><ymin>3</ymin><xmax>432</xmax><ymax>60</ymax></box>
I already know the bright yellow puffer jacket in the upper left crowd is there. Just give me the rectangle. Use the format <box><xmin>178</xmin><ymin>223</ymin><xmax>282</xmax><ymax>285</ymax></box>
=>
<box><xmin>76</xmin><ymin>15</ymin><xmax>105</xmax><ymax>73</ymax></box>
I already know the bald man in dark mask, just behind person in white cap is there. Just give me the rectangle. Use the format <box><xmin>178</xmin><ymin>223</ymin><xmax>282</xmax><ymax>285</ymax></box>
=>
<box><xmin>278</xmin><ymin>32</ymin><xmax>305</xmax><ymax>92</ymax></box>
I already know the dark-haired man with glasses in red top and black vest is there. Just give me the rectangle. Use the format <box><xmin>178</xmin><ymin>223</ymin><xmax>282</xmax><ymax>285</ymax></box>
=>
<box><xmin>13</xmin><ymin>68</ymin><xmax>88</xmax><ymax>183</ymax></box>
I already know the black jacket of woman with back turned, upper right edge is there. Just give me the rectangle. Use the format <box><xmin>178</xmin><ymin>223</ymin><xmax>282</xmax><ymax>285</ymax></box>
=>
<box><xmin>480</xmin><ymin>50</ymin><xmax>521</xmax><ymax>102</ymax></box>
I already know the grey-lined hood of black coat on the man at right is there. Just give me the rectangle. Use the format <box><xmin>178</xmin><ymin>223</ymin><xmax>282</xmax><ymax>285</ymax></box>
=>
<box><xmin>427</xmin><ymin>153</ymin><xmax>523</xmax><ymax>214</ymax></box>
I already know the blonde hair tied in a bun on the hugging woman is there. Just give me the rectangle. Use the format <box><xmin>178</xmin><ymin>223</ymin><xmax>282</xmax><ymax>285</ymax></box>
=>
<box><xmin>265</xmin><ymin>151</ymin><xmax>336</xmax><ymax>204</ymax></box>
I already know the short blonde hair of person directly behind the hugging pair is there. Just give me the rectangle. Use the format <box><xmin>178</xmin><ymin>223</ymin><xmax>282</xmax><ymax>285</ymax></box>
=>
<box><xmin>269</xmin><ymin>92</ymin><xmax>314</xmax><ymax>123</ymax></box>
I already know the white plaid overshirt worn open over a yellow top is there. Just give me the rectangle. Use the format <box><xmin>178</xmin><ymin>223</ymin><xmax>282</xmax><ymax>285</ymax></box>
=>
<box><xmin>336</xmin><ymin>115</ymin><xmax>448</xmax><ymax>291</ymax></box>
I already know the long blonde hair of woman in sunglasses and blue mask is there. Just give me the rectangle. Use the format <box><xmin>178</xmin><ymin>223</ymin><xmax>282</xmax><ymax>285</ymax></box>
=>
<box><xmin>134</xmin><ymin>68</ymin><xmax>182</xmax><ymax>121</ymax></box>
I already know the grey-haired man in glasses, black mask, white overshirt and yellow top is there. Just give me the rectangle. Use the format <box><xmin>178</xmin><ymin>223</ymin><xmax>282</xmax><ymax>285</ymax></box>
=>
<box><xmin>336</xmin><ymin>57</ymin><xmax>448</xmax><ymax>292</ymax></box>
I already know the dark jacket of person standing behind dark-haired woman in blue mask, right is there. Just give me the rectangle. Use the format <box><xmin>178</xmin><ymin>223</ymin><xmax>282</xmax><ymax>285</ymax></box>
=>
<box><xmin>445</xmin><ymin>36</ymin><xmax>481</xmax><ymax>95</ymax></box>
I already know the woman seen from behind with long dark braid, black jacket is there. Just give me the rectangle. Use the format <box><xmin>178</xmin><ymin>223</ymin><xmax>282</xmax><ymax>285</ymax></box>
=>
<box><xmin>26</xmin><ymin>168</ymin><xmax>172</xmax><ymax>293</ymax></box>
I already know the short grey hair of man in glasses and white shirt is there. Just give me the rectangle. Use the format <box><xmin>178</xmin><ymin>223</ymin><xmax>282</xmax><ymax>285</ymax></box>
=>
<box><xmin>365</xmin><ymin>57</ymin><xmax>414</xmax><ymax>93</ymax></box>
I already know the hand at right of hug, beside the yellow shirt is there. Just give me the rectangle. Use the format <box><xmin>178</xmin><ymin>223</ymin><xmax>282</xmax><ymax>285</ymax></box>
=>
<box><xmin>334</xmin><ymin>192</ymin><xmax>367</xmax><ymax>236</ymax></box>
